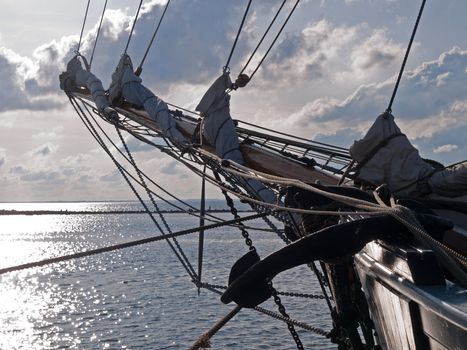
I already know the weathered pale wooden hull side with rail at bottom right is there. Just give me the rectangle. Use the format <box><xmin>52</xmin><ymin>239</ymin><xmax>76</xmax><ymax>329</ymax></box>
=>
<box><xmin>354</xmin><ymin>242</ymin><xmax>467</xmax><ymax>350</ymax></box>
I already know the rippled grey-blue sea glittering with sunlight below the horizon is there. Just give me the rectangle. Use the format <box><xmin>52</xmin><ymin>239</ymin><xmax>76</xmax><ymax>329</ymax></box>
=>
<box><xmin>0</xmin><ymin>201</ymin><xmax>336</xmax><ymax>349</ymax></box>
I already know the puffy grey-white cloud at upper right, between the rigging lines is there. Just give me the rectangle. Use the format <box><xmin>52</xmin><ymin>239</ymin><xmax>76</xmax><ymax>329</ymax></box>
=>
<box><xmin>254</xmin><ymin>19</ymin><xmax>403</xmax><ymax>86</ymax></box>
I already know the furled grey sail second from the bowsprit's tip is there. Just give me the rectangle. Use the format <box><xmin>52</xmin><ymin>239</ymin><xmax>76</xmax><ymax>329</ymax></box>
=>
<box><xmin>109</xmin><ymin>54</ymin><xmax>186</xmax><ymax>144</ymax></box>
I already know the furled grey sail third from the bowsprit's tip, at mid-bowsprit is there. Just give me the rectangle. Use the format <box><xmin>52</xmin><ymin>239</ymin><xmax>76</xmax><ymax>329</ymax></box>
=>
<box><xmin>196</xmin><ymin>73</ymin><xmax>276</xmax><ymax>203</ymax></box>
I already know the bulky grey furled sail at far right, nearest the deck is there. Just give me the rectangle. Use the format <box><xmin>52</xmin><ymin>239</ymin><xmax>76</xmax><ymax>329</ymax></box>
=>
<box><xmin>350</xmin><ymin>113</ymin><xmax>467</xmax><ymax>197</ymax></box>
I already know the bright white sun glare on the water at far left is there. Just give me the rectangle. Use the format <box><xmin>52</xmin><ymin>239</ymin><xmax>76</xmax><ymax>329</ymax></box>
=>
<box><xmin>0</xmin><ymin>209</ymin><xmax>84</xmax><ymax>349</ymax></box>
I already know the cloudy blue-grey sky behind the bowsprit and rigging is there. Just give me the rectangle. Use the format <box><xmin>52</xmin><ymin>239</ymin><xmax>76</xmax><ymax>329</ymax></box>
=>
<box><xmin>0</xmin><ymin>0</ymin><xmax>467</xmax><ymax>202</ymax></box>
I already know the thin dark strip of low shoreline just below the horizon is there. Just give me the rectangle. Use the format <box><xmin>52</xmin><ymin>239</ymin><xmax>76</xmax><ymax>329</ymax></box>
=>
<box><xmin>0</xmin><ymin>209</ymin><xmax>252</xmax><ymax>216</ymax></box>
